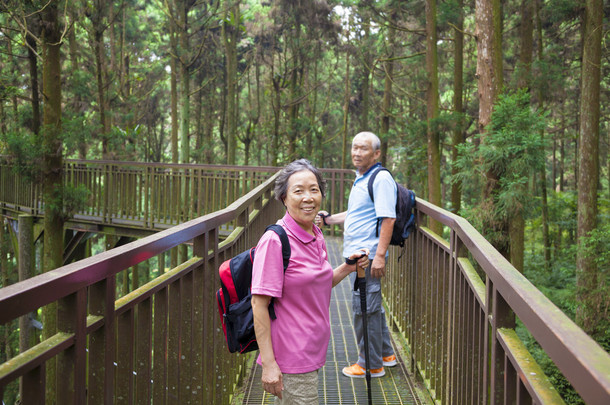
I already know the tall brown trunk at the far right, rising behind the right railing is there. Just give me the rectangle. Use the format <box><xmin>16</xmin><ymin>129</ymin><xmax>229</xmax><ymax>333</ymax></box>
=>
<box><xmin>576</xmin><ymin>0</ymin><xmax>607</xmax><ymax>335</ymax></box>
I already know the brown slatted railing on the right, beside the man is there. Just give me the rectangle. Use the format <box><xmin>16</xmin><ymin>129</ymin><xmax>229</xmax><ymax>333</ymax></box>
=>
<box><xmin>383</xmin><ymin>199</ymin><xmax>610</xmax><ymax>405</ymax></box>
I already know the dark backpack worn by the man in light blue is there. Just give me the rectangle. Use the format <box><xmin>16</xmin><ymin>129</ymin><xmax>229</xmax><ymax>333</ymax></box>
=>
<box><xmin>368</xmin><ymin>166</ymin><xmax>415</xmax><ymax>247</ymax></box>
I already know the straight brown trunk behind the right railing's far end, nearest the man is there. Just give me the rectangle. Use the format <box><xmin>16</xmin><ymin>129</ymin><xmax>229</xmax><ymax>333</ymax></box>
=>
<box><xmin>426</xmin><ymin>0</ymin><xmax>443</xmax><ymax>235</ymax></box>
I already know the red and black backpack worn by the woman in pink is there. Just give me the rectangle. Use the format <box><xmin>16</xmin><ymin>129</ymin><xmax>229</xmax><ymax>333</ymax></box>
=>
<box><xmin>216</xmin><ymin>224</ymin><xmax>290</xmax><ymax>353</ymax></box>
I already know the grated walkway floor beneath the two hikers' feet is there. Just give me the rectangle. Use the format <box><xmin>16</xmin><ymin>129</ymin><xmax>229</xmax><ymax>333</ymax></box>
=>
<box><xmin>242</xmin><ymin>237</ymin><xmax>425</xmax><ymax>405</ymax></box>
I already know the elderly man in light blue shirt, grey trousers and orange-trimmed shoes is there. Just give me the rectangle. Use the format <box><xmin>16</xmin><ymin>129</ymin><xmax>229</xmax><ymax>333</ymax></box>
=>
<box><xmin>316</xmin><ymin>132</ymin><xmax>397</xmax><ymax>378</ymax></box>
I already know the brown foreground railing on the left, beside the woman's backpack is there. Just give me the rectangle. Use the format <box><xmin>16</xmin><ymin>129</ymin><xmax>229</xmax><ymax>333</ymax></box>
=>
<box><xmin>0</xmin><ymin>173</ymin><xmax>283</xmax><ymax>404</ymax></box>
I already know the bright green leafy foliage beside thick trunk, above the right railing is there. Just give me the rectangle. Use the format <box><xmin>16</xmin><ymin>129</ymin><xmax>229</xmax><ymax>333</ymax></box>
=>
<box><xmin>453</xmin><ymin>90</ymin><xmax>545</xmax><ymax>240</ymax></box>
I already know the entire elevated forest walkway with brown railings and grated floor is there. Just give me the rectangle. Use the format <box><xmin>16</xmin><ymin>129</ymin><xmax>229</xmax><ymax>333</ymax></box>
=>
<box><xmin>0</xmin><ymin>162</ymin><xmax>610</xmax><ymax>405</ymax></box>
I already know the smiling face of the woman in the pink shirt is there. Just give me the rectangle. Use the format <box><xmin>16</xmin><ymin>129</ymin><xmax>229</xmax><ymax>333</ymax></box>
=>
<box><xmin>284</xmin><ymin>170</ymin><xmax>322</xmax><ymax>231</ymax></box>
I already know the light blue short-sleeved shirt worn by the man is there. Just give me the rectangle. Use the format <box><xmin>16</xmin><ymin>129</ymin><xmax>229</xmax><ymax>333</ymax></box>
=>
<box><xmin>343</xmin><ymin>163</ymin><xmax>396</xmax><ymax>259</ymax></box>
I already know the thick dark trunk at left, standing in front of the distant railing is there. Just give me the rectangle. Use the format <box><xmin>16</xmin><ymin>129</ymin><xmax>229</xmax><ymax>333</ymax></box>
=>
<box><xmin>41</xmin><ymin>2</ymin><xmax>64</xmax><ymax>403</ymax></box>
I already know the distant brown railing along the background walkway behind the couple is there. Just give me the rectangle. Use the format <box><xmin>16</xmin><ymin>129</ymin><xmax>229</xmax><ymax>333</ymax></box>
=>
<box><xmin>0</xmin><ymin>157</ymin><xmax>353</xmax><ymax>230</ymax></box>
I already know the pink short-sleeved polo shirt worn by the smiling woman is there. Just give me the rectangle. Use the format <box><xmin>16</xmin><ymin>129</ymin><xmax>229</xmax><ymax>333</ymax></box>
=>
<box><xmin>252</xmin><ymin>213</ymin><xmax>333</xmax><ymax>374</ymax></box>
